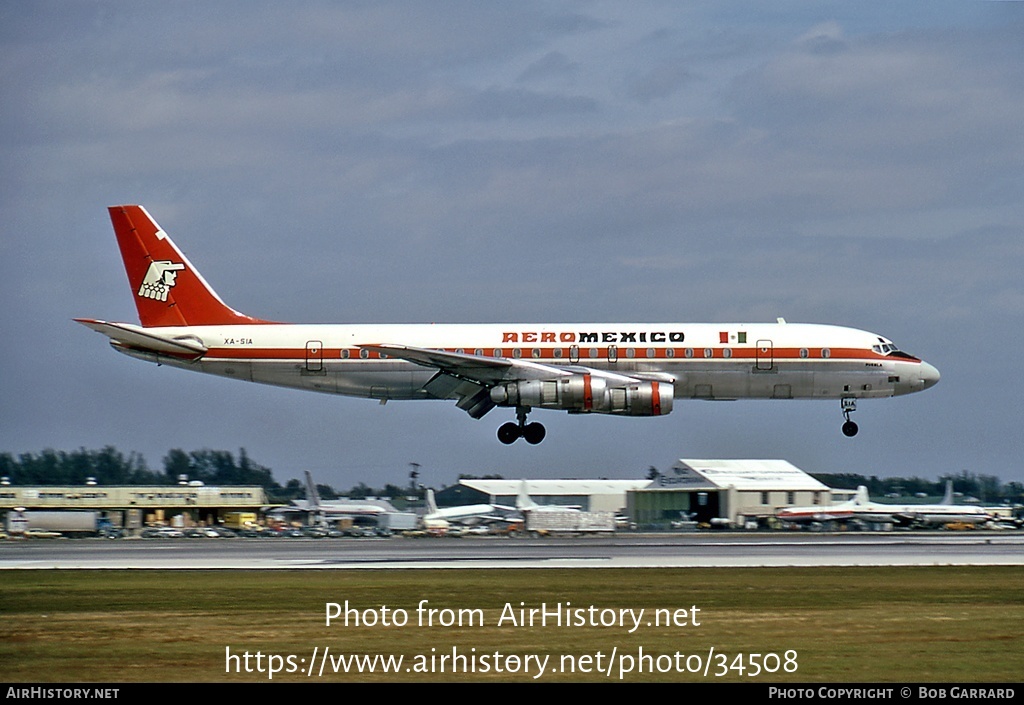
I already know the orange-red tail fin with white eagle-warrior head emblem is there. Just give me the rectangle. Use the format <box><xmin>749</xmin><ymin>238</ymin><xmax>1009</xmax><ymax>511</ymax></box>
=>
<box><xmin>108</xmin><ymin>206</ymin><xmax>270</xmax><ymax>328</ymax></box>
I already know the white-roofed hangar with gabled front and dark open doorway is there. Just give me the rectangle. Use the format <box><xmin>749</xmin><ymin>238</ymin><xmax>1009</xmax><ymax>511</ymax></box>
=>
<box><xmin>627</xmin><ymin>459</ymin><xmax>833</xmax><ymax>528</ymax></box>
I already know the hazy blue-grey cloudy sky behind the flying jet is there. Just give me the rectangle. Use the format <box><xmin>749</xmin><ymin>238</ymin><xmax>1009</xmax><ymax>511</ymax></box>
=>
<box><xmin>0</xmin><ymin>0</ymin><xmax>1024</xmax><ymax>488</ymax></box>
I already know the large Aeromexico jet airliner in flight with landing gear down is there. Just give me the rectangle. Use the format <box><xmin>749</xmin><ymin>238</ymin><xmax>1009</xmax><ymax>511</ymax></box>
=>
<box><xmin>75</xmin><ymin>205</ymin><xmax>939</xmax><ymax>445</ymax></box>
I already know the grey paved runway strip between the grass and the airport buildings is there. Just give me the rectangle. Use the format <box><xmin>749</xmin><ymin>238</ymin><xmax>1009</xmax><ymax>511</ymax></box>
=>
<box><xmin>0</xmin><ymin>532</ymin><xmax>1024</xmax><ymax>570</ymax></box>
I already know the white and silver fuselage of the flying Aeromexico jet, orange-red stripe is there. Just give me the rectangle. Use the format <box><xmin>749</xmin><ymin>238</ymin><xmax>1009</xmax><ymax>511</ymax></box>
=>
<box><xmin>115</xmin><ymin>323</ymin><xmax>938</xmax><ymax>400</ymax></box>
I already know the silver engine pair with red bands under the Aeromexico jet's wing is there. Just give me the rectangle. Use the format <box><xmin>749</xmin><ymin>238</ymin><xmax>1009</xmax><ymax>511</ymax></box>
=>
<box><xmin>490</xmin><ymin>374</ymin><xmax>675</xmax><ymax>416</ymax></box>
